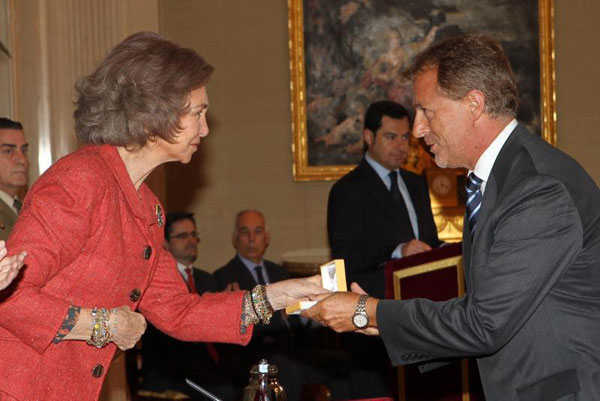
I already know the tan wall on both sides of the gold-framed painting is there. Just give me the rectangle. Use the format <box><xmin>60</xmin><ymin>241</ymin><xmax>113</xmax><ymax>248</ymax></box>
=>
<box><xmin>161</xmin><ymin>0</ymin><xmax>600</xmax><ymax>270</ymax></box>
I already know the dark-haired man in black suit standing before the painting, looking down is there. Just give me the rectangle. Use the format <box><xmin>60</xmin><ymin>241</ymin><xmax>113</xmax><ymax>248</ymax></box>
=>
<box><xmin>327</xmin><ymin>100</ymin><xmax>440</xmax><ymax>398</ymax></box>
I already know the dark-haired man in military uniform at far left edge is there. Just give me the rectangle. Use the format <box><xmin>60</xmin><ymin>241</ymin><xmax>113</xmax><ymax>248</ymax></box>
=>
<box><xmin>0</xmin><ymin>117</ymin><xmax>29</xmax><ymax>240</ymax></box>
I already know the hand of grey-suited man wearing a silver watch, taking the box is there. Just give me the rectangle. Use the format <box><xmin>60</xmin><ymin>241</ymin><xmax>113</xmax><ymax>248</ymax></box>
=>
<box><xmin>302</xmin><ymin>283</ymin><xmax>379</xmax><ymax>335</ymax></box>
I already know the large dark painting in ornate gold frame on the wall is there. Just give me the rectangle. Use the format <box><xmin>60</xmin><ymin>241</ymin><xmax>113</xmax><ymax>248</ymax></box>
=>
<box><xmin>288</xmin><ymin>0</ymin><xmax>556</xmax><ymax>181</ymax></box>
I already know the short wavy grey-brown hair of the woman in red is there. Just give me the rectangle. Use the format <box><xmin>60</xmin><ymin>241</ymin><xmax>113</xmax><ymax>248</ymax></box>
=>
<box><xmin>73</xmin><ymin>32</ymin><xmax>214</xmax><ymax>148</ymax></box>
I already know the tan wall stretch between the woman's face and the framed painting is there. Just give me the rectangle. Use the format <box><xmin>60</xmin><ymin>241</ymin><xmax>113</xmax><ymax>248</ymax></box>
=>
<box><xmin>161</xmin><ymin>0</ymin><xmax>331</xmax><ymax>270</ymax></box>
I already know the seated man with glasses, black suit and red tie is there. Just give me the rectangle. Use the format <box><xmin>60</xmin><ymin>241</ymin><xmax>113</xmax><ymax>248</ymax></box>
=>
<box><xmin>142</xmin><ymin>211</ymin><xmax>235</xmax><ymax>401</ymax></box>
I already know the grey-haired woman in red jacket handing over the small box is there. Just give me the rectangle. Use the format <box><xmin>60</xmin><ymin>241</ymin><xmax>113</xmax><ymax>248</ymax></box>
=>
<box><xmin>0</xmin><ymin>32</ymin><xmax>324</xmax><ymax>401</ymax></box>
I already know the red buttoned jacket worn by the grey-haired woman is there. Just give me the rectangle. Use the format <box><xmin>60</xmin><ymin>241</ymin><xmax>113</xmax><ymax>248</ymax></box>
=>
<box><xmin>0</xmin><ymin>145</ymin><xmax>252</xmax><ymax>401</ymax></box>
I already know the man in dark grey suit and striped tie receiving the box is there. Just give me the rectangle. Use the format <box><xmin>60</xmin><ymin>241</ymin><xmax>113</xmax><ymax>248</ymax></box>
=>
<box><xmin>308</xmin><ymin>36</ymin><xmax>600</xmax><ymax>401</ymax></box>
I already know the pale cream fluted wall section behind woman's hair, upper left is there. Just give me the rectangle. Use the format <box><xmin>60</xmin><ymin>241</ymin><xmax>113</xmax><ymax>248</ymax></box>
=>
<box><xmin>8</xmin><ymin>0</ymin><xmax>164</xmax><ymax>198</ymax></box>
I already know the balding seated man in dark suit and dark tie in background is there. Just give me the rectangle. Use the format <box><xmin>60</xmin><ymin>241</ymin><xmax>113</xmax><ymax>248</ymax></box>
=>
<box><xmin>213</xmin><ymin>210</ymin><xmax>303</xmax><ymax>400</ymax></box>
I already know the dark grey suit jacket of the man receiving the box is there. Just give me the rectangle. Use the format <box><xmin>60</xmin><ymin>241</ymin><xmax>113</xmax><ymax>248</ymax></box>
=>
<box><xmin>377</xmin><ymin>125</ymin><xmax>600</xmax><ymax>401</ymax></box>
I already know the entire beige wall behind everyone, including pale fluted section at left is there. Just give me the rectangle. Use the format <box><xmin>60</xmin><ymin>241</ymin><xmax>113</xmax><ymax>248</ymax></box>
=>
<box><xmin>8</xmin><ymin>0</ymin><xmax>600</xmax><ymax>270</ymax></box>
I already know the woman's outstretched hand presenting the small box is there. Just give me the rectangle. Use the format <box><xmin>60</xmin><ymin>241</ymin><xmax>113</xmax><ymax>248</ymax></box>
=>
<box><xmin>266</xmin><ymin>274</ymin><xmax>330</xmax><ymax>310</ymax></box>
